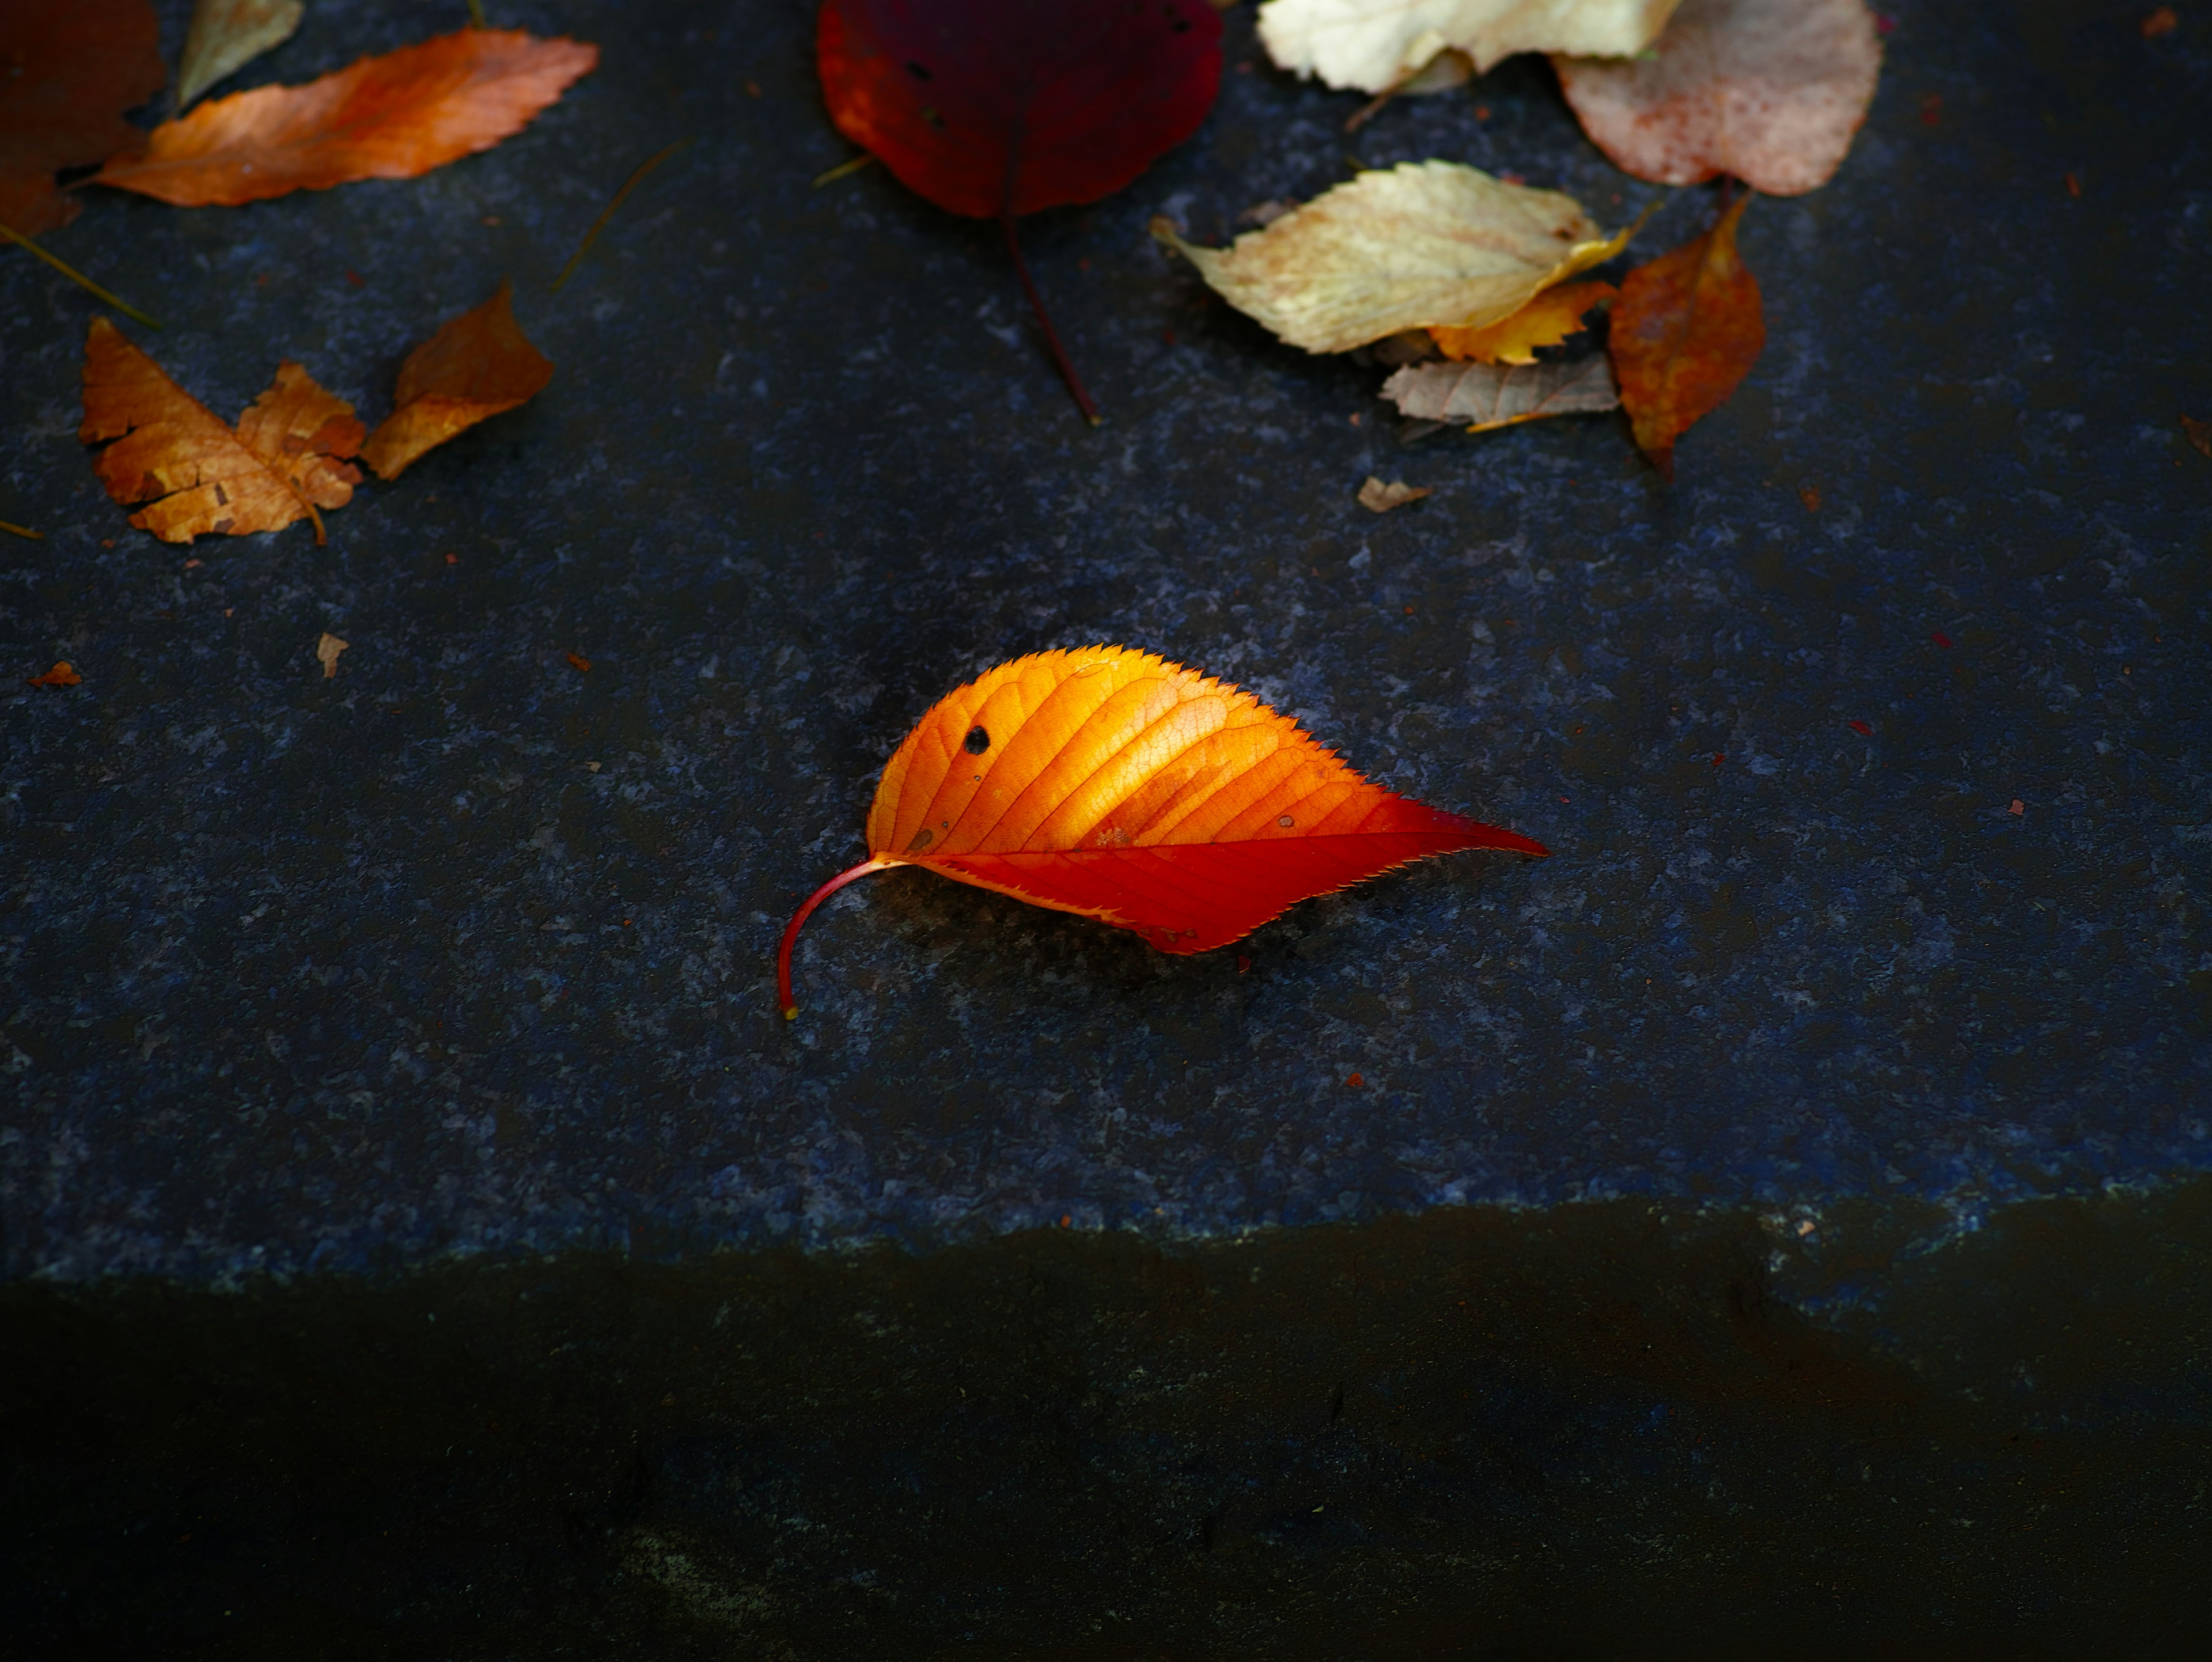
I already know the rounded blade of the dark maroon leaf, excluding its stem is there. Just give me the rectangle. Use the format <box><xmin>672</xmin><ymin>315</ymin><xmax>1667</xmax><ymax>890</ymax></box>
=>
<box><xmin>814</xmin><ymin>0</ymin><xmax>1221</xmax><ymax>219</ymax></box>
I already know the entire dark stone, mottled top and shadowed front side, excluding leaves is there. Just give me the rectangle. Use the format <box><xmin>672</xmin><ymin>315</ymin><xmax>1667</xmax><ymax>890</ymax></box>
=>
<box><xmin>0</xmin><ymin>0</ymin><xmax>2212</xmax><ymax>1662</ymax></box>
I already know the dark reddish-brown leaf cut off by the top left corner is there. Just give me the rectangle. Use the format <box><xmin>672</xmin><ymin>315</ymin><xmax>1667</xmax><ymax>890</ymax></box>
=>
<box><xmin>0</xmin><ymin>0</ymin><xmax>168</xmax><ymax>237</ymax></box>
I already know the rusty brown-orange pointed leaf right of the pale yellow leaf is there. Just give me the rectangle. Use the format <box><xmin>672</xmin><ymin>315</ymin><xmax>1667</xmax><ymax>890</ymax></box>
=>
<box><xmin>1611</xmin><ymin>195</ymin><xmax>1767</xmax><ymax>478</ymax></box>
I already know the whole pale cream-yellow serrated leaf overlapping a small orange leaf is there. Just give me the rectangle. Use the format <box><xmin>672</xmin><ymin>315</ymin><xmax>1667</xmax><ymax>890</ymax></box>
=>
<box><xmin>1153</xmin><ymin>161</ymin><xmax>1628</xmax><ymax>352</ymax></box>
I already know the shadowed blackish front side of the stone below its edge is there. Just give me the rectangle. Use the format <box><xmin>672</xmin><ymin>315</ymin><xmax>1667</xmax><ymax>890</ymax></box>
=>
<box><xmin>13</xmin><ymin>1182</ymin><xmax>2212</xmax><ymax>1662</ymax></box>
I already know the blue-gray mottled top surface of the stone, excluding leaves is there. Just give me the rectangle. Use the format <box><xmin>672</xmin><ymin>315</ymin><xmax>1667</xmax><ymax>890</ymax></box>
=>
<box><xmin>0</xmin><ymin>0</ymin><xmax>2212</xmax><ymax>1279</ymax></box>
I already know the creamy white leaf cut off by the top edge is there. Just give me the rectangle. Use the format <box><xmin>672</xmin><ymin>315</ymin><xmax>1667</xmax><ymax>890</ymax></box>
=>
<box><xmin>1259</xmin><ymin>0</ymin><xmax>1681</xmax><ymax>93</ymax></box>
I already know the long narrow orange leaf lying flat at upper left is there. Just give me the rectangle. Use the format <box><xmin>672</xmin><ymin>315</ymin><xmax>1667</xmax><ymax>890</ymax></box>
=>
<box><xmin>93</xmin><ymin>29</ymin><xmax>600</xmax><ymax>208</ymax></box>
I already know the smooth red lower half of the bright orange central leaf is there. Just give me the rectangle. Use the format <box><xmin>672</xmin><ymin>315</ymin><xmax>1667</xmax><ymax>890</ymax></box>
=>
<box><xmin>914</xmin><ymin>801</ymin><xmax>1551</xmax><ymax>954</ymax></box>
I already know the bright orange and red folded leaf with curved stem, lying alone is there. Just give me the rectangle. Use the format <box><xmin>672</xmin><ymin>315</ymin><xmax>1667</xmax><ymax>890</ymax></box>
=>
<box><xmin>777</xmin><ymin>646</ymin><xmax>1548</xmax><ymax>1016</ymax></box>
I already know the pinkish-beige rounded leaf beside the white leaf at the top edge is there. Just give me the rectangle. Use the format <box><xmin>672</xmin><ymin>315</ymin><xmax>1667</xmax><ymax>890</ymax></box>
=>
<box><xmin>1557</xmin><ymin>0</ymin><xmax>1883</xmax><ymax>197</ymax></box>
